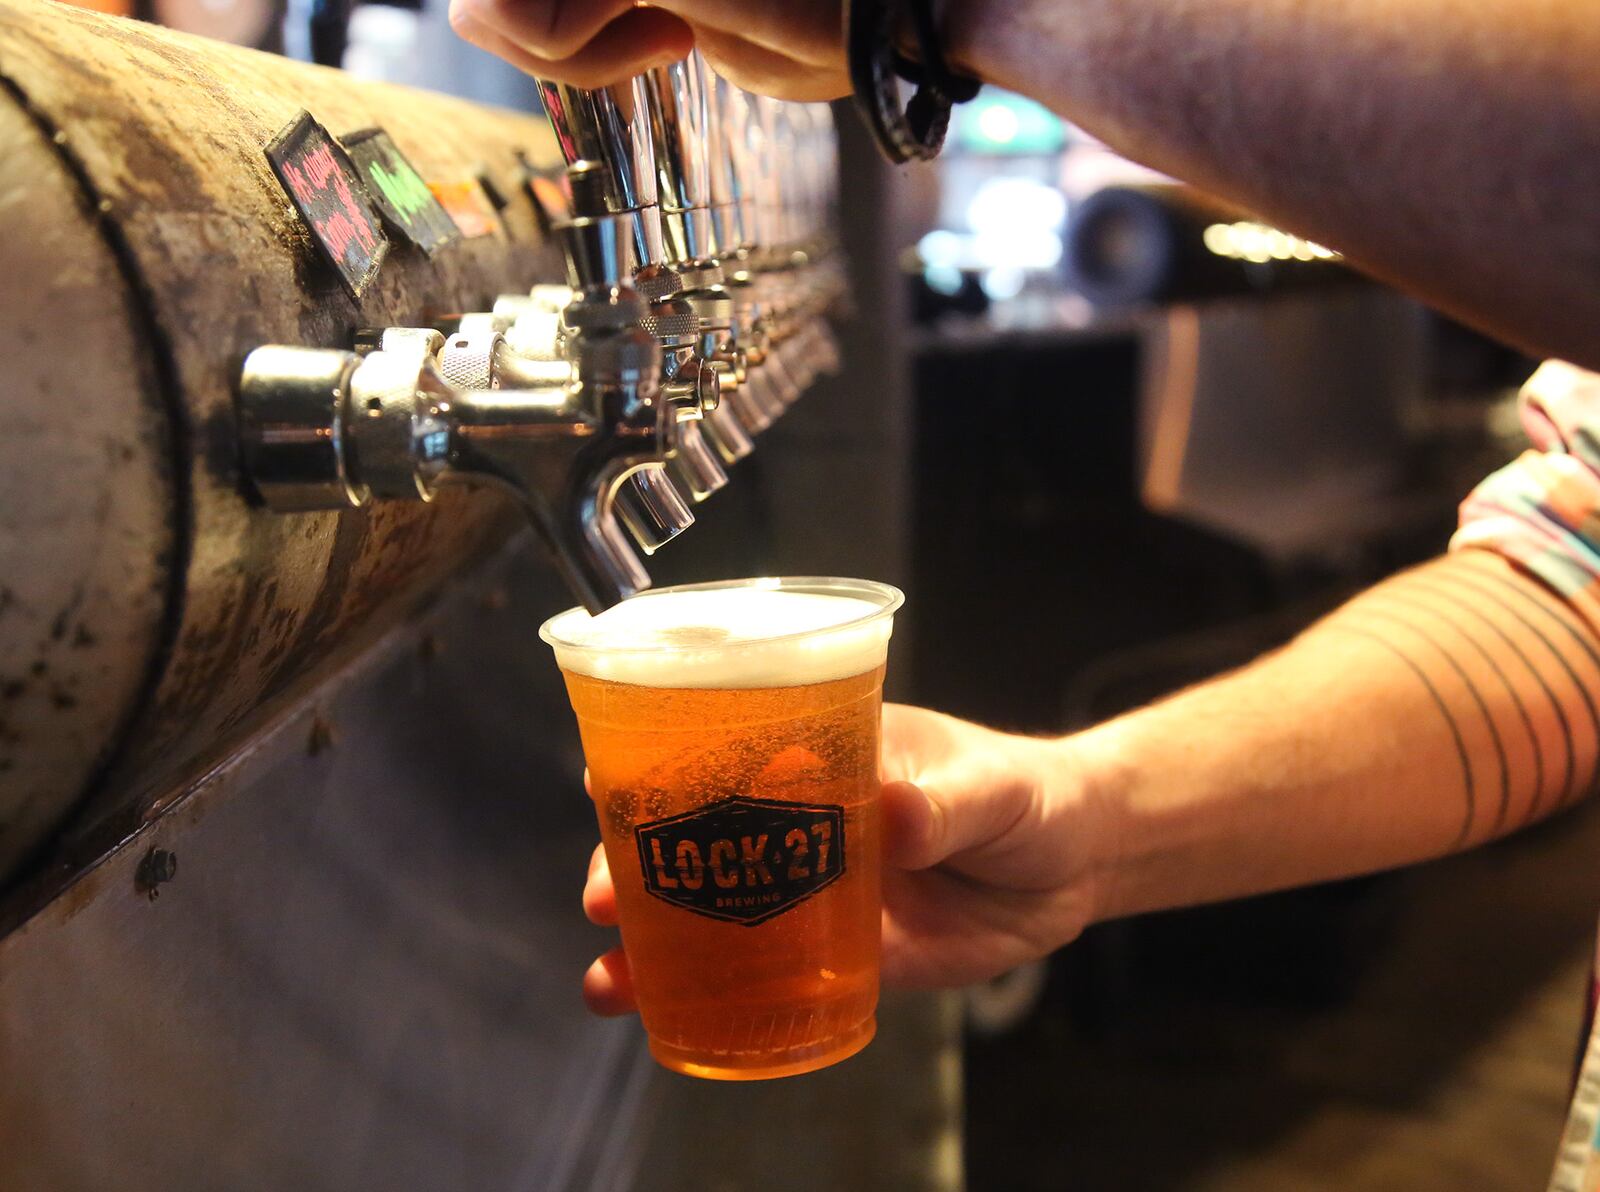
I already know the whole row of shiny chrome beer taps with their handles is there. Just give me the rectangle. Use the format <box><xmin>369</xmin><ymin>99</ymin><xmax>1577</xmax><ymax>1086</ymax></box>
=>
<box><xmin>240</xmin><ymin>53</ymin><xmax>843</xmax><ymax>611</ymax></box>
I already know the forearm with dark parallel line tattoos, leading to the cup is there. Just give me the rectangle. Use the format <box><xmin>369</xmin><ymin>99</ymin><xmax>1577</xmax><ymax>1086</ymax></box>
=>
<box><xmin>1069</xmin><ymin>552</ymin><xmax>1600</xmax><ymax>918</ymax></box>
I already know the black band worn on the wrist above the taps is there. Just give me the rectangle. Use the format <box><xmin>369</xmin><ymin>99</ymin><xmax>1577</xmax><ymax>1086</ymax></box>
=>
<box><xmin>845</xmin><ymin>0</ymin><xmax>981</xmax><ymax>163</ymax></box>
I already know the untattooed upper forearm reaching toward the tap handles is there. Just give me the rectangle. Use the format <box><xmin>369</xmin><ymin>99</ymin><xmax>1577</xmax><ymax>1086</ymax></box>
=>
<box><xmin>949</xmin><ymin>0</ymin><xmax>1600</xmax><ymax>366</ymax></box>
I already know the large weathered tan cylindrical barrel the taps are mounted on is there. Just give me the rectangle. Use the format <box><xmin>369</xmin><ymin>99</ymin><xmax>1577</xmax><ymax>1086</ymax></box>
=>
<box><xmin>0</xmin><ymin>0</ymin><xmax>562</xmax><ymax>896</ymax></box>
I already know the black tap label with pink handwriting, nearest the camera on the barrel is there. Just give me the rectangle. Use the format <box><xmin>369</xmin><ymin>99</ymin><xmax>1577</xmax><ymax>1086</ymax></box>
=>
<box><xmin>267</xmin><ymin>112</ymin><xmax>389</xmax><ymax>299</ymax></box>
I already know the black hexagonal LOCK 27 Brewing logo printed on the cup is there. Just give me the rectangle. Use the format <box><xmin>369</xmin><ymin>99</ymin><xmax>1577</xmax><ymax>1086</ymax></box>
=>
<box><xmin>634</xmin><ymin>797</ymin><xmax>845</xmax><ymax>926</ymax></box>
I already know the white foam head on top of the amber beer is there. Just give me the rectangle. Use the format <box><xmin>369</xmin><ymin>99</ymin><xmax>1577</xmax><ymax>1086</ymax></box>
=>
<box><xmin>546</xmin><ymin>587</ymin><xmax>894</xmax><ymax>688</ymax></box>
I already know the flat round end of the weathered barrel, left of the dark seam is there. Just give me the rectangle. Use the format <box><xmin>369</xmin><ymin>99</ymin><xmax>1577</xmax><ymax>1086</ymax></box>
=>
<box><xmin>0</xmin><ymin>99</ymin><xmax>174</xmax><ymax>874</ymax></box>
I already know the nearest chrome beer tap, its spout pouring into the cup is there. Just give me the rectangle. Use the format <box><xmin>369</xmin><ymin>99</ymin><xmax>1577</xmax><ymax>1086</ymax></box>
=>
<box><xmin>238</xmin><ymin>163</ymin><xmax>715</xmax><ymax>611</ymax></box>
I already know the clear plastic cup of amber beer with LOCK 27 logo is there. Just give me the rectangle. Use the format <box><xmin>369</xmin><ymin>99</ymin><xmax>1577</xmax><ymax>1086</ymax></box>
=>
<box><xmin>539</xmin><ymin>579</ymin><xmax>902</xmax><ymax>1080</ymax></box>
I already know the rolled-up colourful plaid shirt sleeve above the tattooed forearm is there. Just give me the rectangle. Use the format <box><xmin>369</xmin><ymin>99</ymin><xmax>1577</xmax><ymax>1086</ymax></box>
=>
<box><xmin>1450</xmin><ymin>362</ymin><xmax>1600</xmax><ymax>621</ymax></box>
